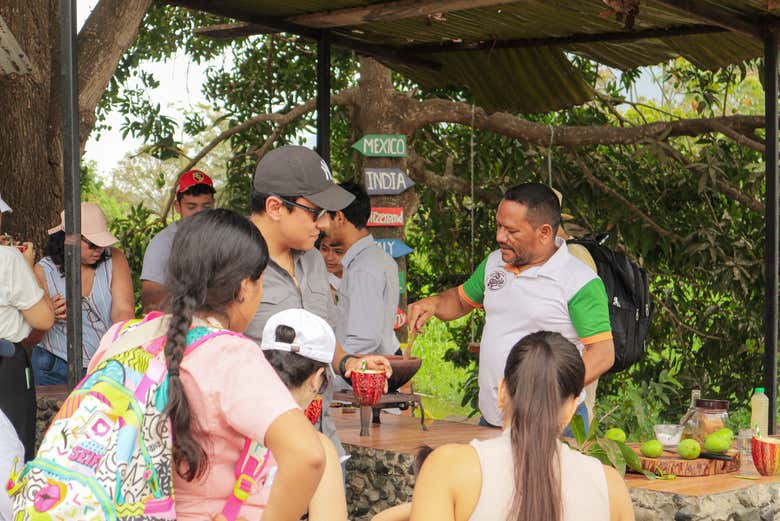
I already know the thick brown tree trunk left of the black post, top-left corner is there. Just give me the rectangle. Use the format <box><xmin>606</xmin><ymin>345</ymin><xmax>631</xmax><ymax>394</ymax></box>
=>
<box><xmin>0</xmin><ymin>0</ymin><xmax>62</xmax><ymax>245</ymax></box>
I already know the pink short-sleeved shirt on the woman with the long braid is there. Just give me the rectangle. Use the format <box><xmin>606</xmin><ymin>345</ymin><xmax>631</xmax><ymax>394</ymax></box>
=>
<box><xmin>90</xmin><ymin>320</ymin><xmax>298</xmax><ymax>521</ymax></box>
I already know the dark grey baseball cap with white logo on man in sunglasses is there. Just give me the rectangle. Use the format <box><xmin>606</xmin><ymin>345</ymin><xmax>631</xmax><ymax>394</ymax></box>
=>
<box><xmin>252</xmin><ymin>145</ymin><xmax>355</xmax><ymax>212</ymax></box>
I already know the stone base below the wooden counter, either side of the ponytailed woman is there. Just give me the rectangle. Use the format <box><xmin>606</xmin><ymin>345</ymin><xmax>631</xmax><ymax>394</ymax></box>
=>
<box><xmin>344</xmin><ymin>444</ymin><xmax>780</xmax><ymax>521</ymax></box>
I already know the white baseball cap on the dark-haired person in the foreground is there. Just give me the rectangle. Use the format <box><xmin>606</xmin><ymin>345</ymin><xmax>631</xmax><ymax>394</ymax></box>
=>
<box><xmin>260</xmin><ymin>309</ymin><xmax>336</xmax><ymax>364</ymax></box>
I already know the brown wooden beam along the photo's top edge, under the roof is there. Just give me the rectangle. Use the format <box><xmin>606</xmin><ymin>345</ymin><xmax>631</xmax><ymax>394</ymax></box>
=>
<box><xmin>288</xmin><ymin>0</ymin><xmax>517</xmax><ymax>29</ymax></box>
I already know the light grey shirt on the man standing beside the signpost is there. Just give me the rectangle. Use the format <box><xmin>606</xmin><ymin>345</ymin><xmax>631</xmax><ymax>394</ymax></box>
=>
<box><xmin>335</xmin><ymin>235</ymin><xmax>399</xmax><ymax>355</ymax></box>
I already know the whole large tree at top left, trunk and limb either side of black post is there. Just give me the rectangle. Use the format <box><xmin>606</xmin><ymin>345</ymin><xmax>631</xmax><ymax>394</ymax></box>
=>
<box><xmin>0</xmin><ymin>0</ymin><xmax>151</xmax><ymax>247</ymax></box>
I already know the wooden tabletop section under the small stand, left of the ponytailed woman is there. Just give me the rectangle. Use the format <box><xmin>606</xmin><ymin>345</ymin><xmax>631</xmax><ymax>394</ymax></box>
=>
<box><xmin>331</xmin><ymin>409</ymin><xmax>501</xmax><ymax>454</ymax></box>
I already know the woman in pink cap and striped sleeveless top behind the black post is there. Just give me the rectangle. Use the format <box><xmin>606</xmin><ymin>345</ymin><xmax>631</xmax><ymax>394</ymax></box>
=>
<box><xmin>32</xmin><ymin>203</ymin><xmax>134</xmax><ymax>385</ymax></box>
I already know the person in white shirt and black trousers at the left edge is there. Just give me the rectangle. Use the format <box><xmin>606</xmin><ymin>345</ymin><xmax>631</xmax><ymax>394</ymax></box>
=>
<box><xmin>0</xmin><ymin>194</ymin><xmax>54</xmax><ymax>459</ymax></box>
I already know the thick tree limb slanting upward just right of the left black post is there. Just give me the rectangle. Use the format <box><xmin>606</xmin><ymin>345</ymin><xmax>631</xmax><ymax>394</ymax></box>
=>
<box><xmin>77</xmin><ymin>0</ymin><xmax>152</xmax><ymax>153</ymax></box>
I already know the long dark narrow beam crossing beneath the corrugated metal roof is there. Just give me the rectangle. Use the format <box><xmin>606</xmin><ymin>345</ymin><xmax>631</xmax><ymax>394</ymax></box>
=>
<box><xmin>402</xmin><ymin>25</ymin><xmax>728</xmax><ymax>54</ymax></box>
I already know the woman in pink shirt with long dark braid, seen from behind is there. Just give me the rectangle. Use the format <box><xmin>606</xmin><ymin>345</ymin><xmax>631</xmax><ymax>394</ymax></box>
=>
<box><xmin>90</xmin><ymin>209</ymin><xmax>325</xmax><ymax>521</ymax></box>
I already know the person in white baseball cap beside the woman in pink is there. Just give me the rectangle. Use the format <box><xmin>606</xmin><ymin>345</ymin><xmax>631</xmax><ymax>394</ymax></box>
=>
<box><xmin>261</xmin><ymin>309</ymin><xmax>347</xmax><ymax>521</ymax></box>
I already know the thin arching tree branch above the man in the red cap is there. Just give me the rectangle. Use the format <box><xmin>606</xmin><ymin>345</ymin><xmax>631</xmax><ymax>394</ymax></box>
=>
<box><xmin>162</xmin><ymin>87</ymin><xmax>357</xmax><ymax>221</ymax></box>
